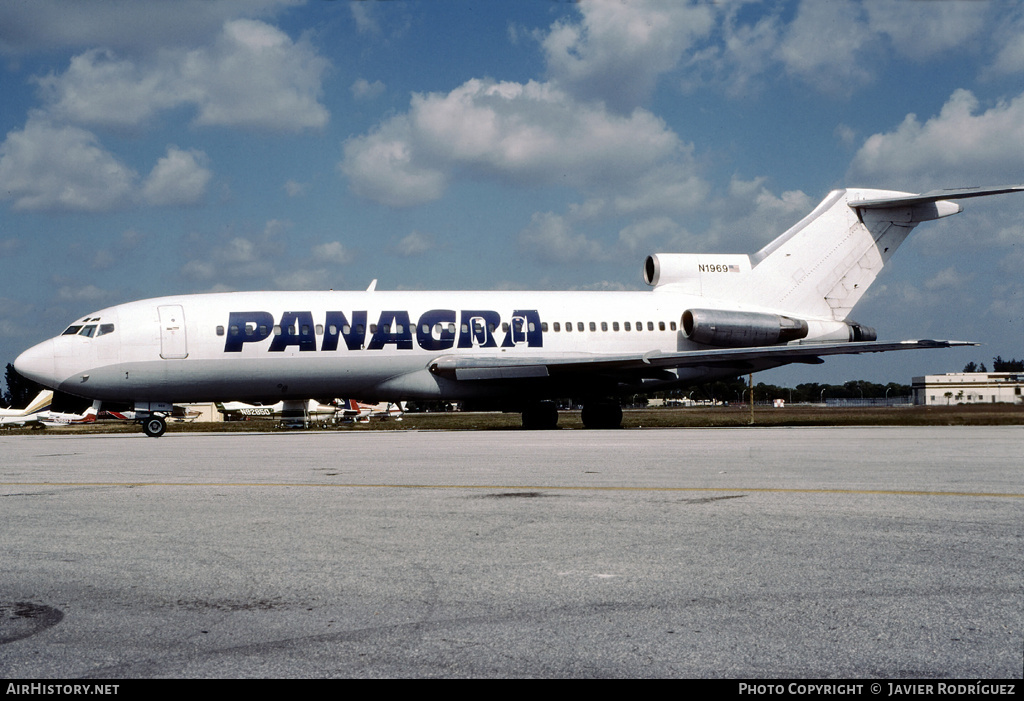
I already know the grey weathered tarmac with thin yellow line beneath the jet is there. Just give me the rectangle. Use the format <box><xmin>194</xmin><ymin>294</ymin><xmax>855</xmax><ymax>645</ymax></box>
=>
<box><xmin>0</xmin><ymin>427</ymin><xmax>1024</xmax><ymax>680</ymax></box>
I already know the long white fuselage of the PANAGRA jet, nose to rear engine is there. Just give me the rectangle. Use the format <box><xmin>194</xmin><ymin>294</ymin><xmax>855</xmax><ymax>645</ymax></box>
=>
<box><xmin>12</xmin><ymin>291</ymin><xmax>831</xmax><ymax>402</ymax></box>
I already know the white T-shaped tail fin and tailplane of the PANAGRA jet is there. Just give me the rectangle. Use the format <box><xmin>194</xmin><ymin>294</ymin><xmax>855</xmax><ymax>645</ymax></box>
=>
<box><xmin>746</xmin><ymin>185</ymin><xmax>1024</xmax><ymax>321</ymax></box>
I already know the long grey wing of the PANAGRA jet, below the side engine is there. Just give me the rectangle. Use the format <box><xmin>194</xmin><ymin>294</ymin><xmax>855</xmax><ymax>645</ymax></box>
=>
<box><xmin>429</xmin><ymin>340</ymin><xmax>978</xmax><ymax>381</ymax></box>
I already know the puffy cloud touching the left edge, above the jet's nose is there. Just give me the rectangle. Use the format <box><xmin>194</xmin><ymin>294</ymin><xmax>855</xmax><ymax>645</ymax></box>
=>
<box><xmin>0</xmin><ymin>116</ymin><xmax>138</xmax><ymax>212</ymax></box>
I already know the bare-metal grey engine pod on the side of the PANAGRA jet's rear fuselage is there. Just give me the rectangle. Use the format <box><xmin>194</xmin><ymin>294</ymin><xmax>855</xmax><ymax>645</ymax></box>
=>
<box><xmin>682</xmin><ymin>309</ymin><xmax>808</xmax><ymax>348</ymax></box>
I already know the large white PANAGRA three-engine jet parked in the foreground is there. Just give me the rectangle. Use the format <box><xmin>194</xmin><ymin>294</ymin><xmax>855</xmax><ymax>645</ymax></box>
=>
<box><xmin>14</xmin><ymin>185</ymin><xmax>1024</xmax><ymax>437</ymax></box>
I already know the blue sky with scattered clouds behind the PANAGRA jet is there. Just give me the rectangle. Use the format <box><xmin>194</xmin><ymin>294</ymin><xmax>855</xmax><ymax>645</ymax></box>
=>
<box><xmin>0</xmin><ymin>0</ymin><xmax>1024</xmax><ymax>385</ymax></box>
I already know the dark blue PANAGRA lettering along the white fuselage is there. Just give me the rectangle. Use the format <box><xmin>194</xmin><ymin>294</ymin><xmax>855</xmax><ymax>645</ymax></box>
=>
<box><xmin>224</xmin><ymin>309</ymin><xmax>544</xmax><ymax>353</ymax></box>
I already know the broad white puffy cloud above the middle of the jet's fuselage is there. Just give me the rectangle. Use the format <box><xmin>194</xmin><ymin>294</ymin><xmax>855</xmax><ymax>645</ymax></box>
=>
<box><xmin>340</xmin><ymin>79</ymin><xmax>680</xmax><ymax>206</ymax></box>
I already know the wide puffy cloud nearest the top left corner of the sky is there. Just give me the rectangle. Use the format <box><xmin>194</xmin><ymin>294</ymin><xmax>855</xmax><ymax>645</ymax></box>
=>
<box><xmin>37</xmin><ymin>19</ymin><xmax>329</xmax><ymax>131</ymax></box>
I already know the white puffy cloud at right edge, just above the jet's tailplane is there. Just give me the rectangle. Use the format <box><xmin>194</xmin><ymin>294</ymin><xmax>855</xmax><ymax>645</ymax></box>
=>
<box><xmin>850</xmin><ymin>89</ymin><xmax>1024</xmax><ymax>187</ymax></box>
